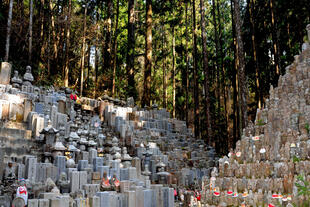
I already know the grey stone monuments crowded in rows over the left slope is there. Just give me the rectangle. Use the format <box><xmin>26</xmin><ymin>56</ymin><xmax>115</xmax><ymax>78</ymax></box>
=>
<box><xmin>0</xmin><ymin>62</ymin><xmax>217</xmax><ymax>207</ymax></box>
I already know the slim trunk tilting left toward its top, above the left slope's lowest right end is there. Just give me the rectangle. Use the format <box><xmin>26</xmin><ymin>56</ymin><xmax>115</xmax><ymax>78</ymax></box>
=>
<box><xmin>200</xmin><ymin>0</ymin><xmax>212</xmax><ymax>144</ymax></box>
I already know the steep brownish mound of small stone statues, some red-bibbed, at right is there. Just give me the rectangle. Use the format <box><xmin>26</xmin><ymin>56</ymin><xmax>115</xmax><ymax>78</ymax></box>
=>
<box><xmin>203</xmin><ymin>28</ymin><xmax>310</xmax><ymax>206</ymax></box>
